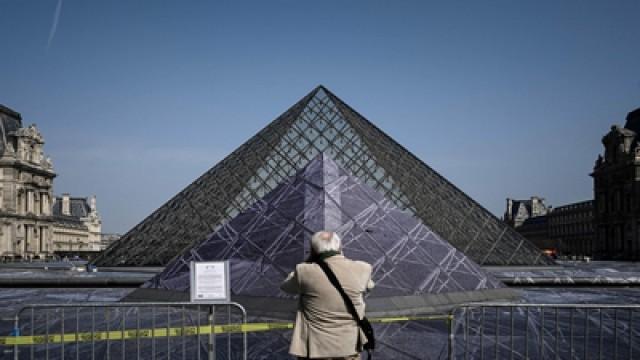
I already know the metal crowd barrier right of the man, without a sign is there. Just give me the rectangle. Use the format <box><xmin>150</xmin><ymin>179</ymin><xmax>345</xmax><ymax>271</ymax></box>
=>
<box><xmin>448</xmin><ymin>303</ymin><xmax>640</xmax><ymax>360</ymax></box>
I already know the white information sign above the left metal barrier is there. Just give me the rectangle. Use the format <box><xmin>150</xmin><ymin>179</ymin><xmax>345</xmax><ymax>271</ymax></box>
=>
<box><xmin>190</xmin><ymin>261</ymin><xmax>231</xmax><ymax>302</ymax></box>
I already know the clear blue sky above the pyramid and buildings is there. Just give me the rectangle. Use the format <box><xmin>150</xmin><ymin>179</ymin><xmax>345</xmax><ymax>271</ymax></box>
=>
<box><xmin>0</xmin><ymin>0</ymin><xmax>640</xmax><ymax>232</ymax></box>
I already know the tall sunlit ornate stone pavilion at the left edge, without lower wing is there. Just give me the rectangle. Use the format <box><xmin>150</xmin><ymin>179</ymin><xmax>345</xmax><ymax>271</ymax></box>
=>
<box><xmin>0</xmin><ymin>105</ymin><xmax>56</xmax><ymax>259</ymax></box>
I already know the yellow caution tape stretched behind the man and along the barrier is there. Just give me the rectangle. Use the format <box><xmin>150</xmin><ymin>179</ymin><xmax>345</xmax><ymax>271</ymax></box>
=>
<box><xmin>0</xmin><ymin>315</ymin><xmax>451</xmax><ymax>346</ymax></box>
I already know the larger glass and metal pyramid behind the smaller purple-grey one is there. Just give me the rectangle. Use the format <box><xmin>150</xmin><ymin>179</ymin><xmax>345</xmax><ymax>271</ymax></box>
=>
<box><xmin>94</xmin><ymin>86</ymin><xmax>552</xmax><ymax>266</ymax></box>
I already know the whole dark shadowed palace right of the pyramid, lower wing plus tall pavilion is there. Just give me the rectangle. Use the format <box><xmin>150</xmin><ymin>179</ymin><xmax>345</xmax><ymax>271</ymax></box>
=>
<box><xmin>505</xmin><ymin>105</ymin><xmax>640</xmax><ymax>261</ymax></box>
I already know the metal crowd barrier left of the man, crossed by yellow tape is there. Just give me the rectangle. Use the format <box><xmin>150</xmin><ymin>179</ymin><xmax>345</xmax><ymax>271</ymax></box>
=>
<box><xmin>13</xmin><ymin>302</ymin><xmax>247</xmax><ymax>360</ymax></box>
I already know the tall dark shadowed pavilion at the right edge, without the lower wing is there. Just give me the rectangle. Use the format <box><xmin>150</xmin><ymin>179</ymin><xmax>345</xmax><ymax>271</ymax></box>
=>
<box><xmin>591</xmin><ymin>109</ymin><xmax>640</xmax><ymax>260</ymax></box>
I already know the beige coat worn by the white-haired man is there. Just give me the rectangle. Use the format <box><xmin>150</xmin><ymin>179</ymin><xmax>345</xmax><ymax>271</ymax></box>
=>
<box><xmin>280</xmin><ymin>255</ymin><xmax>373</xmax><ymax>358</ymax></box>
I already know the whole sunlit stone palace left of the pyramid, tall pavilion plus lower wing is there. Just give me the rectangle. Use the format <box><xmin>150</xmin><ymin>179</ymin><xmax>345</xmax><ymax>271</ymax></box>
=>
<box><xmin>0</xmin><ymin>105</ymin><xmax>102</xmax><ymax>259</ymax></box>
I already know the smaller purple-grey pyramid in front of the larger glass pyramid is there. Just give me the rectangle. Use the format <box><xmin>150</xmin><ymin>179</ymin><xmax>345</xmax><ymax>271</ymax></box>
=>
<box><xmin>136</xmin><ymin>154</ymin><xmax>512</xmax><ymax>315</ymax></box>
